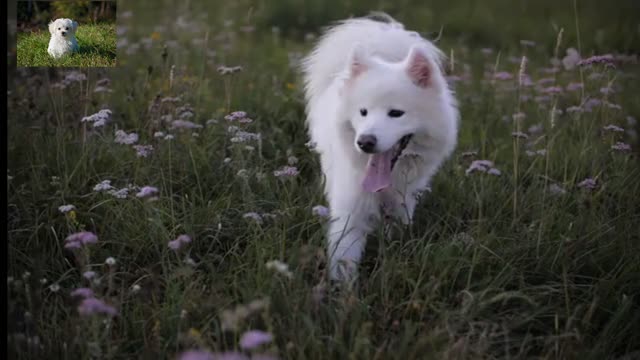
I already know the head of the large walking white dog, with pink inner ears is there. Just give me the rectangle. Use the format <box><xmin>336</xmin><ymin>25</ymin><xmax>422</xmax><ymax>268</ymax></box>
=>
<box><xmin>340</xmin><ymin>44</ymin><xmax>455</xmax><ymax>154</ymax></box>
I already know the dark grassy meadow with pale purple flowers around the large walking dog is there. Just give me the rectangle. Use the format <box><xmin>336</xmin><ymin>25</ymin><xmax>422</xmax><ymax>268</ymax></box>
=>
<box><xmin>7</xmin><ymin>0</ymin><xmax>640</xmax><ymax>360</ymax></box>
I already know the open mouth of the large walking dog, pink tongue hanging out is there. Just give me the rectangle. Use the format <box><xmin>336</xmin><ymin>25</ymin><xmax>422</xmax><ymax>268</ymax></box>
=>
<box><xmin>362</xmin><ymin>134</ymin><xmax>413</xmax><ymax>192</ymax></box>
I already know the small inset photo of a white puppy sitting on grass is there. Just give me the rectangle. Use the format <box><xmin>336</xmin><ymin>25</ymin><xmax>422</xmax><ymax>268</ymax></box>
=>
<box><xmin>17</xmin><ymin>0</ymin><xmax>117</xmax><ymax>67</ymax></box>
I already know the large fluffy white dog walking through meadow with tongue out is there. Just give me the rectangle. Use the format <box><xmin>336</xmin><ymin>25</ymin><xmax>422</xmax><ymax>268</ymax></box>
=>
<box><xmin>303</xmin><ymin>14</ymin><xmax>459</xmax><ymax>281</ymax></box>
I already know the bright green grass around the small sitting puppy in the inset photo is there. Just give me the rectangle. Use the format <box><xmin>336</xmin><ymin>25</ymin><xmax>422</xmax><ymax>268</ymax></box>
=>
<box><xmin>17</xmin><ymin>24</ymin><xmax>116</xmax><ymax>67</ymax></box>
